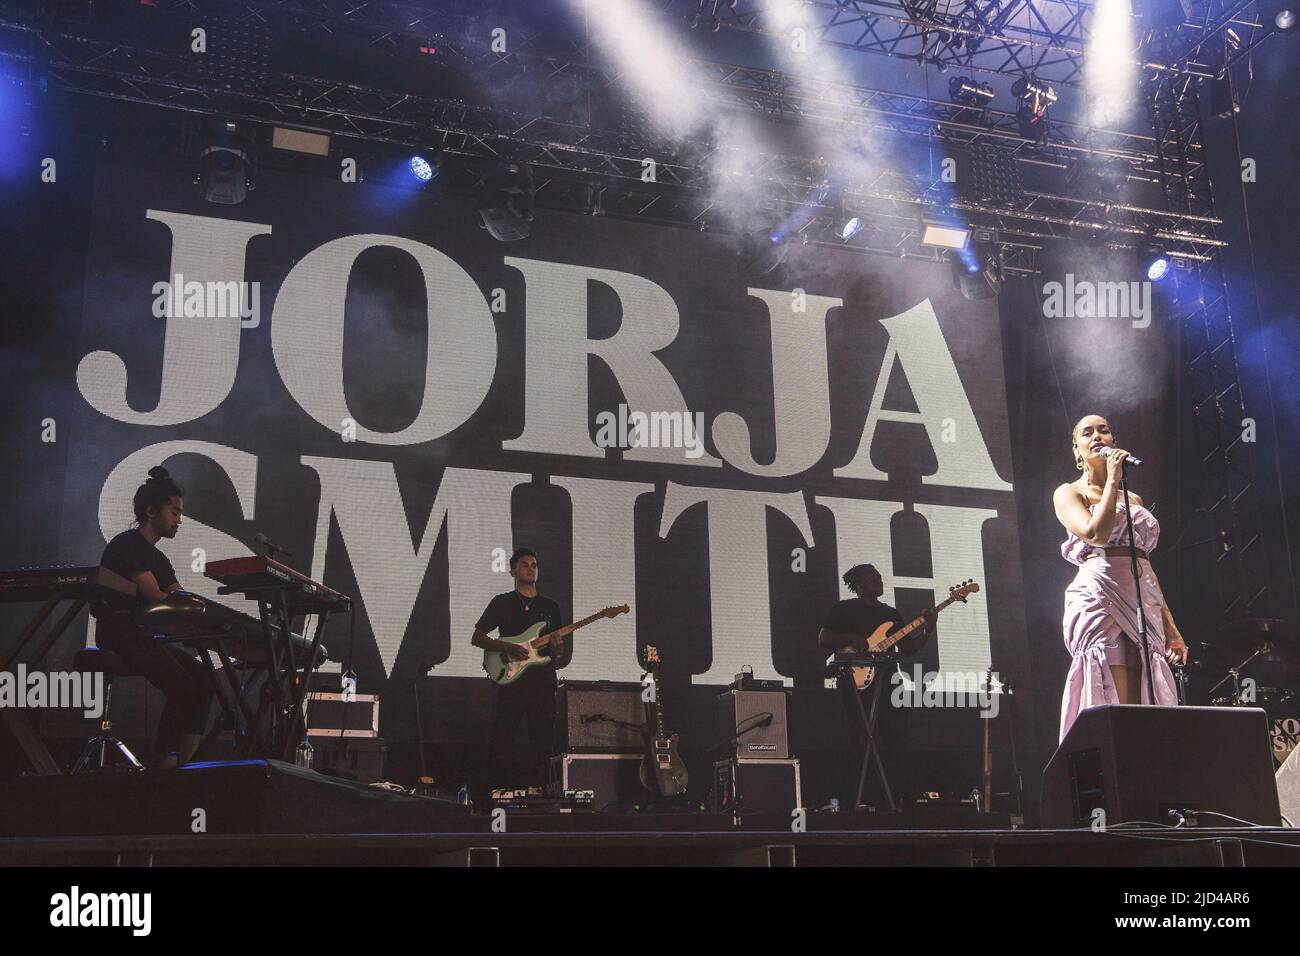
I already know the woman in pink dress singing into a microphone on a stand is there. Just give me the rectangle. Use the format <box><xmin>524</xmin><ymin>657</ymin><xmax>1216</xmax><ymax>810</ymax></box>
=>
<box><xmin>1052</xmin><ymin>415</ymin><xmax>1187</xmax><ymax>740</ymax></box>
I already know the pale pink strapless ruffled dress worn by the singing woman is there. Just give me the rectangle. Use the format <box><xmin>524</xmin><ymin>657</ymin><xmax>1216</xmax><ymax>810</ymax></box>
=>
<box><xmin>1061</xmin><ymin>501</ymin><xmax>1178</xmax><ymax>740</ymax></box>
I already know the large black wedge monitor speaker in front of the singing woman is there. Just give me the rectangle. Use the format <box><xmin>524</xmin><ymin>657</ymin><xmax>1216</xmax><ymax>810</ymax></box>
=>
<box><xmin>1040</xmin><ymin>705</ymin><xmax>1281</xmax><ymax>829</ymax></box>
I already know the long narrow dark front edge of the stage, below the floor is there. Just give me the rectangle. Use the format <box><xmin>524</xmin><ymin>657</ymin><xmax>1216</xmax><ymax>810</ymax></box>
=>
<box><xmin>0</xmin><ymin>821</ymin><xmax>1300</xmax><ymax>868</ymax></box>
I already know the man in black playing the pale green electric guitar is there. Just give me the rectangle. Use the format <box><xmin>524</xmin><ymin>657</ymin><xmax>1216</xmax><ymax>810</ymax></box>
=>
<box><xmin>471</xmin><ymin>548</ymin><xmax>566</xmax><ymax>788</ymax></box>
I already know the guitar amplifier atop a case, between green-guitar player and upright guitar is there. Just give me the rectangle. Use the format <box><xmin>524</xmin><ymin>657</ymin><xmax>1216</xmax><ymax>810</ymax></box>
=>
<box><xmin>555</xmin><ymin>680</ymin><xmax>646</xmax><ymax>756</ymax></box>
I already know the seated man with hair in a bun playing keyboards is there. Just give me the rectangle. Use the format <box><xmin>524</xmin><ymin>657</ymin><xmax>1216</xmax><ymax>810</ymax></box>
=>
<box><xmin>95</xmin><ymin>467</ymin><xmax>213</xmax><ymax>770</ymax></box>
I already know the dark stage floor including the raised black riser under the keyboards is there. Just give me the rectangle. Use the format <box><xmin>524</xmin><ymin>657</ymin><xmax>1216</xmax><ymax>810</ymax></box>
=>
<box><xmin>0</xmin><ymin>760</ymin><xmax>1300</xmax><ymax>866</ymax></box>
